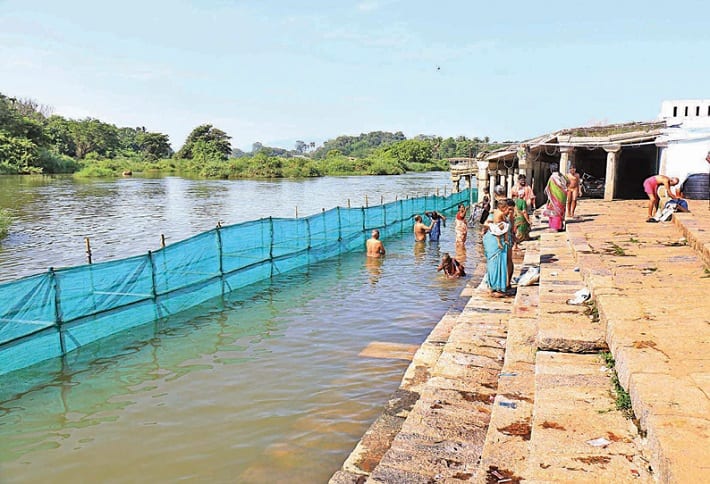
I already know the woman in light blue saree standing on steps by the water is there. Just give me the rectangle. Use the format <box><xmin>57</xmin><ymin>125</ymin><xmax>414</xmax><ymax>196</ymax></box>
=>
<box><xmin>483</xmin><ymin>199</ymin><xmax>511</xmax><ymax>297</ymax></box>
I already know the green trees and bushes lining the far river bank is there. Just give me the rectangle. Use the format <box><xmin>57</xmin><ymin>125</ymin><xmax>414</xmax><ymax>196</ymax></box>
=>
<box><xmin>0</xmin><ymin>93</ymin><xmax>506</xmax><ymax>178</ymax></box>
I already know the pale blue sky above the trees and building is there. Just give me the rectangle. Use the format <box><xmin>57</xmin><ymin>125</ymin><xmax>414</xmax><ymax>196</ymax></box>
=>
<box><xmin>0</xmin><ymin>0</ymin><xmax>710</xmax><ymax>151</ymax></box>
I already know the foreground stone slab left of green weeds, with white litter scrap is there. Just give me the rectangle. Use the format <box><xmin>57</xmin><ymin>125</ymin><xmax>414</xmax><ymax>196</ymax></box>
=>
<box><xmin>523</xmin><ymin>351</ymin><xmax>653</xmax><ymax>483</ymax></box>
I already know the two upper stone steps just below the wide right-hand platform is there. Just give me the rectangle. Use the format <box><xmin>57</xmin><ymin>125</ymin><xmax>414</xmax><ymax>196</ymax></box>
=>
<box><xmin>476</xmin><ymin>225</ymin><xmax>651</xmax><ymax>483</ymax></box>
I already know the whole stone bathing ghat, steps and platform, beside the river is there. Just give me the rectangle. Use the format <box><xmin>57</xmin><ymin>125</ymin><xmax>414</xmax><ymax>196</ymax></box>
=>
<box><xmin>331</xmin><ymin>200</ymin><xmax>710</xmax><ymax>483</ymax></box>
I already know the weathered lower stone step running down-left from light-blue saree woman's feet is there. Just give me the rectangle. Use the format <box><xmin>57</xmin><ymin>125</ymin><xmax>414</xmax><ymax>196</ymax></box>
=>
<box><xmin>367</xmin><ymin>274</ymin><xmax>512</xmax><ymax>483</ymax></box>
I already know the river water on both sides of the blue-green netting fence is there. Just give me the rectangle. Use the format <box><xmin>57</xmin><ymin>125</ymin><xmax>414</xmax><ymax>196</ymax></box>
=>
<box><xmin>0</xmin><ymin>173</ymin><xmax>477</xmax><ymax>483</ymax></box>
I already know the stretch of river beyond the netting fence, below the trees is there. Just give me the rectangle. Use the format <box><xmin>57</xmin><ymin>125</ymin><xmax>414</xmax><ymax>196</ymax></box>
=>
<box><xmin>0</xmin><ymin>172</ymin><xmax>464</xmax><ymax>282</ymax></box>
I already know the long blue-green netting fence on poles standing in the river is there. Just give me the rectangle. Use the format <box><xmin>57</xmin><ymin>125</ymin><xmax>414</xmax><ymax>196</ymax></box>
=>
<box><xmin>0</xmin><ymin>191</ymin><xmax>469</xmax><ymax>374</ymax></box>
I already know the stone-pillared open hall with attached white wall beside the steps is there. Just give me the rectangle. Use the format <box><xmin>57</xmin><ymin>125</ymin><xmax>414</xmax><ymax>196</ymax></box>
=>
<box><xmin>451</xmin><ymin>100</ymin><xmax>710</xmax><ymax>205</ymax></box>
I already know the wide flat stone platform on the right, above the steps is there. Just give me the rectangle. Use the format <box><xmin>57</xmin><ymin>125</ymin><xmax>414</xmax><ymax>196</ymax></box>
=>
<box><xmin>571</xmin><ymin>202</ymin><xmax>710</xmax><ymax>482</ymax></box>
